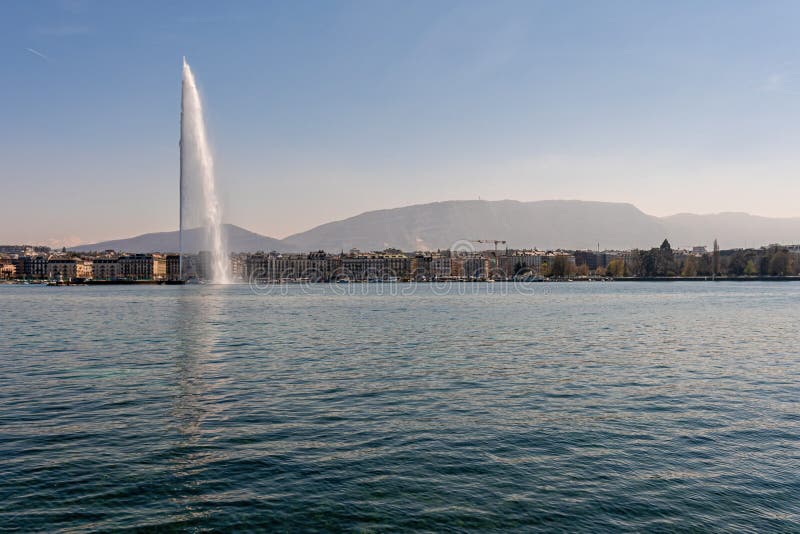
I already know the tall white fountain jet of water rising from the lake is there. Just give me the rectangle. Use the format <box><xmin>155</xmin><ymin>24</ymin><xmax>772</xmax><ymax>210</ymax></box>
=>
<box><xmin>180</xmin><ymin>58</ymin><xmax>230</xmax><ymax>284</ymax></box>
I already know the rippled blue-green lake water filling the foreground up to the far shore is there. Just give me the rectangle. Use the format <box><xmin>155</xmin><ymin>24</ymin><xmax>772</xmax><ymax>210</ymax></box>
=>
<box><xmin>0</xmin><ymin>283</ymin><xmax>800</xmax><ymax>532</ymax></box>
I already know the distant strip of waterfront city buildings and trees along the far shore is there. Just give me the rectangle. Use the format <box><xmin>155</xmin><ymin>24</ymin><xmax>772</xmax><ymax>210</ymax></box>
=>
<box><xmin>0</xmin><ymin>239</ymin><xmax>800</xmax><ymax>285</ymax></box>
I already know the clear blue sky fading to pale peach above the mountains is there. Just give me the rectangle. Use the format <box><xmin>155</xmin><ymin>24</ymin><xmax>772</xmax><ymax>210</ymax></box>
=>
<box><xmin>0</xmin><ymin>0</ymin><xmax>800</xmax><ymax>244</ymax></box>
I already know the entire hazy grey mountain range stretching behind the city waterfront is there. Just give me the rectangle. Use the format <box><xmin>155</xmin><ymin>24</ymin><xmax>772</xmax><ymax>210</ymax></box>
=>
<box><xmin>72</xmin><ymin>200</ymin><xmax>800</xmax><ymax>252</ymax></box>
